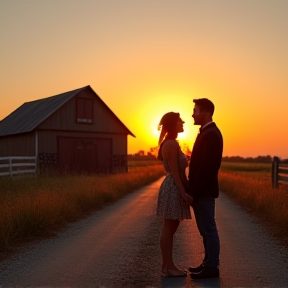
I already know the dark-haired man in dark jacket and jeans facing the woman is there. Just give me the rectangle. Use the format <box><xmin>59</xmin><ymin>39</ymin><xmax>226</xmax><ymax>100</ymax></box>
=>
<box><xmin>187</xmin><ymin>98</ymin><xmax>223</xmax><ymax>279</ymax></box>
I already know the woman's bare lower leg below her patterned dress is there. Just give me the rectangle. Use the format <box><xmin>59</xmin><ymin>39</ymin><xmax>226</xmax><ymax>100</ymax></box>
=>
<box><xmin>160</xmin><ymin>219</ymin><xmax>180</xmax><ymax>271</ymax></box>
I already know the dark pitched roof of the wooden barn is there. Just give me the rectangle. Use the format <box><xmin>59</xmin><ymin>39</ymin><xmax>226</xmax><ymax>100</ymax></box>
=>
<box><xmin>0</xmin><ymin>85</ymin><xmax>135</xmax><ymax>137</ymax></box>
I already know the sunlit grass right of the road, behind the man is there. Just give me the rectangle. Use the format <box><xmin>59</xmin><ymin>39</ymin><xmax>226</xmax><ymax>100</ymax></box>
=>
<box><xmin>219</xmin><ymin>162</ymin><xmax>288</xmax><ymax>248</ymax></box>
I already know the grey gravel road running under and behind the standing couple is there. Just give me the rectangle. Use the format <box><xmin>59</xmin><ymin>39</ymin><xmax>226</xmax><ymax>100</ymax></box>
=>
<box><xmin>0</xmin><ymin>179</ymin><xmax>288</xmax><ymax>288</ymax></box>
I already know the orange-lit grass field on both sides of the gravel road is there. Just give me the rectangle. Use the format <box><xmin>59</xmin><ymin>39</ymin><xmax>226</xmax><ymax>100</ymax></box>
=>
<box><xmin>0</xmin><ymin>160</ymin><xmax>288</xmax><ymax>252</ymax></box>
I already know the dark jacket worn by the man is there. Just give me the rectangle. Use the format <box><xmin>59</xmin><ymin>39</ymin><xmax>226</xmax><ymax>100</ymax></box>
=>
<box><xmin>187</xmin><ymin>122</ymin><xmax>223</xmax><ymax>199</ymax></box>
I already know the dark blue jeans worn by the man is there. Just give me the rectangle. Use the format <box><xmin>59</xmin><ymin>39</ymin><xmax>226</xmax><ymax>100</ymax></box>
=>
<box><xmin>192</xmin><ymin>197</ymin><xmax>220</xmax><ymax>268</ymax></box>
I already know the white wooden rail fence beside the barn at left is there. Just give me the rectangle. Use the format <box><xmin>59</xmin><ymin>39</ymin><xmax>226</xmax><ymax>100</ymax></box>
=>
<box><xmin>0</xmin><ymin>156</ymin><xmax>37</xmax><ymax>176</ymax></box>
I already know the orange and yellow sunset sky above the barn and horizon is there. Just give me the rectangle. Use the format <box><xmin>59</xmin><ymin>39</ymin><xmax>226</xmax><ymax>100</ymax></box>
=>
<box><xmin>0</xmin><ymin>0</ymin><xmax>288</xmax><ymax>158</ymax></box>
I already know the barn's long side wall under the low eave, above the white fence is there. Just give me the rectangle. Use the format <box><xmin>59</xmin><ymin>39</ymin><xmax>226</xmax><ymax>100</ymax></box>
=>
<box><xmin>0</xmin><ymin>132</ymin><xmax>35</xmax><ymax>157</ymax></box>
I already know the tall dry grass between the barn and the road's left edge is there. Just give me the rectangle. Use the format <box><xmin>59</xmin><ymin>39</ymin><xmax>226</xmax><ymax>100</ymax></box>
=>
<box><xmin>0</xmin><ymin>162</ymin><xmax>165</xmax><ymax>252</ymax></box>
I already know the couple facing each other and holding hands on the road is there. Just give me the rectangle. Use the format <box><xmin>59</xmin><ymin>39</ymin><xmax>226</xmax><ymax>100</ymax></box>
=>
<box><xmin>157</xmin><ymin>98</ymin><xmax>223</xmax><ymax>279</ymax></box>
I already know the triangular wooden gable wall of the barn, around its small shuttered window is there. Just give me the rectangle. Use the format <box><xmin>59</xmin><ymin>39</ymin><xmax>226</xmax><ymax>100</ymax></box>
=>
<box><xmin>38</xmin><ymin>89</ymin><xmax>127</xmax><ymax>135</ymax></box>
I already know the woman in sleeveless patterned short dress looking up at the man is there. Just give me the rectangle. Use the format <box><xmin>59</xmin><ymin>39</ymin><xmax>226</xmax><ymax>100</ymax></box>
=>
<box><xmin>157</xmin><ymin>112</ymin><xmax>192</xmax><ymax>277</ymax></box>
